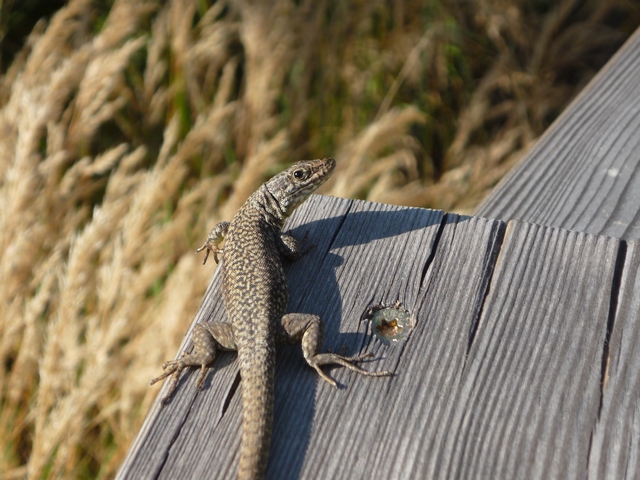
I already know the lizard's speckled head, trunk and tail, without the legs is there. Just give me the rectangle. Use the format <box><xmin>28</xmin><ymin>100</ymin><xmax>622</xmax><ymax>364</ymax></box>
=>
<box><xmin>222</xmin><ymin>159</ymin><xmax>335</xmax><ymax>478</ymax></box>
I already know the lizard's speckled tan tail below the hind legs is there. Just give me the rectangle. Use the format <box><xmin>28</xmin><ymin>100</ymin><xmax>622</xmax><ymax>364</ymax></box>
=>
<box><xmin>238</xmin><ymin>345</ymin><xmax>275</xmax><ymax>480</ymax></box>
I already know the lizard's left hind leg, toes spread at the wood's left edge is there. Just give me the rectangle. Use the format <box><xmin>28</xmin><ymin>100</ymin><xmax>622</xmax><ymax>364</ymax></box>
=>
<box><xmin>149</xmin><ymin>322</ymin><xmax>237</xmax><ymax>404</ymax></box>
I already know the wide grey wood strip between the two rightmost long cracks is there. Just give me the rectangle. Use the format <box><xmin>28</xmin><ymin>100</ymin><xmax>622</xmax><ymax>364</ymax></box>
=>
<box><xmin>438</xmin><ymin>222</ymin><xmax>619</xmax><ymax>479</ymax></box>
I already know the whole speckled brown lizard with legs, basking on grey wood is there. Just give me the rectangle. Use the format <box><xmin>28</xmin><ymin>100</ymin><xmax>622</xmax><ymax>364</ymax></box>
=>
<box><xmin>151</xmin><ymin>157</ymin><xmax>391</xmax><ymax>480</ymax></box>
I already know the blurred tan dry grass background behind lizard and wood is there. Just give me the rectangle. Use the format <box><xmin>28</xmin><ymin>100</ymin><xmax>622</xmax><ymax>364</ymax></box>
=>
<box><xmin>0</xmin><ymin>0</ymin><xmax>640</xmax><ymax>479</ymax></box>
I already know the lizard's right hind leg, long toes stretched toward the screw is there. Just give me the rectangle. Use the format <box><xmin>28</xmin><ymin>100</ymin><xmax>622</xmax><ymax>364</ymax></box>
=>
<box><xmin>276</xmin><ymin>313</ymin><xmax>393</xmax><ymax>387</ymax></box>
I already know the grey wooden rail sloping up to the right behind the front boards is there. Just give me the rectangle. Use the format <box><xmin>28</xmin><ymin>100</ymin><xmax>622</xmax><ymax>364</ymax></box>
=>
<box><xmin>477</xmin><ymin>29</ymin><xmax>640</xmax><ymax>238</ymax></box>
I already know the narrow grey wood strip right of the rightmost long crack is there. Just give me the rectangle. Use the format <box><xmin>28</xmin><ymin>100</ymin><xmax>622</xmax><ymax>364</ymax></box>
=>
<box><xmin>589</xmin><ymin>240</ymin><xmax>640</xmax><ymax>480</ymax></box>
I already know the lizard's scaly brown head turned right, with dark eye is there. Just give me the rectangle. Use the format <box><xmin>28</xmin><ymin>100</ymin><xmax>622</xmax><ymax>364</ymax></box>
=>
<box><xmin>265</xmin><ymin>157</ymin><xmax>336</xmax><ymax>218</ymax></box>
